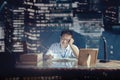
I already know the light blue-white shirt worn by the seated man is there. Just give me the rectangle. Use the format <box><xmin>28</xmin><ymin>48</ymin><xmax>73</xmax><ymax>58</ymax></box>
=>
<box><xmin>46</xmin><ymin>43</ymin><xmax>77</xmax><ymax>59</ymax></box>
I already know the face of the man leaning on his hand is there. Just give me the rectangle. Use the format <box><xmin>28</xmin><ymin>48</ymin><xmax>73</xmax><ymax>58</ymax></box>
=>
<box><xmin>60</xmin><ymin>34</ymin><xmax>72</xmax><ymax>48</ymax></box>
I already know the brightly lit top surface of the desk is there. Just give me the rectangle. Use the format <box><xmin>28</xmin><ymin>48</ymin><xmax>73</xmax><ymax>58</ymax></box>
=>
<box><xmin>16</xmin><ymin>59</ymin><xmax>120</xmax><ymax>69</ymax></box>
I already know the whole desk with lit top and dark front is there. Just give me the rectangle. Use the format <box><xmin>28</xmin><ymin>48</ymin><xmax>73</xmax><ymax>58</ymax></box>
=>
<box><xmin>11</xmin><ymin>59</ymin><xmax>120</xmax><ymax>80</ymax></box>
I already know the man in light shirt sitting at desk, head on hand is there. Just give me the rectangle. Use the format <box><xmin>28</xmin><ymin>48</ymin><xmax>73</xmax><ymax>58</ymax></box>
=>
<box><xmin>45</xmin><ymin>30</ymin><xmax>79</xmax><ymax>59</ymax></box>
